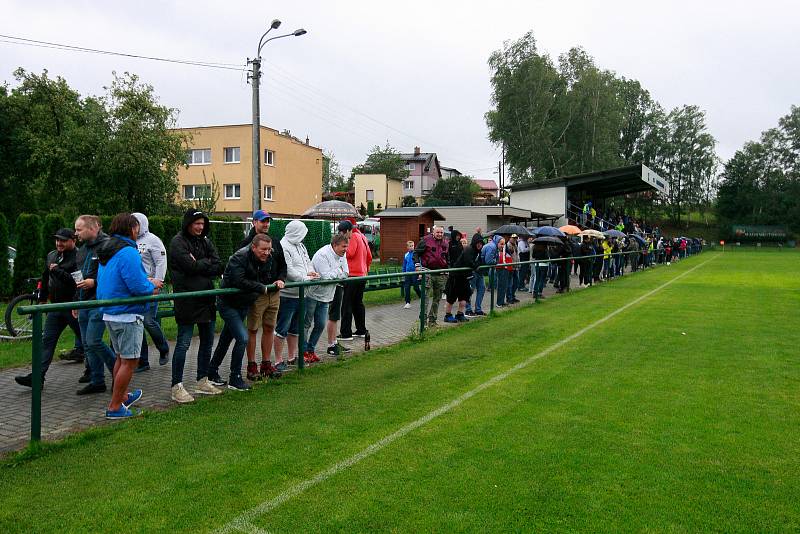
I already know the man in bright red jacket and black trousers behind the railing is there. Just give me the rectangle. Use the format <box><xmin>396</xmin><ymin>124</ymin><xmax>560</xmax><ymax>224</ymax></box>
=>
<box><xmin>339</xmin><ymin>219</ymin><xmax>372</xmax><ymax>341</ymax></box>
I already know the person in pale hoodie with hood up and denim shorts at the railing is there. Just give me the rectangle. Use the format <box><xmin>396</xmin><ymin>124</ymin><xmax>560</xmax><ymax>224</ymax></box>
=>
<box><xmin>274</xmin><ymin>219</ymin><xmax>319</xmax><ymax>372</ymax></box>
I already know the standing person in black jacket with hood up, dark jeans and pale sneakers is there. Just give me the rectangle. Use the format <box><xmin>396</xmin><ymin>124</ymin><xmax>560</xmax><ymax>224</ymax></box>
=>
<box><xmin>167</xmin><ymin>208</ymin><xmax>223</xmax><ymax>403</ymax></box>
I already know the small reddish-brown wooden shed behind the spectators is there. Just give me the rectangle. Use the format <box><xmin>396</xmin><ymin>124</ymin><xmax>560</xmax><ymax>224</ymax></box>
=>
<box><xmin>375</xmin><ymin>207</ymin><xmax>444</xmax><ymax>263</ymax></box>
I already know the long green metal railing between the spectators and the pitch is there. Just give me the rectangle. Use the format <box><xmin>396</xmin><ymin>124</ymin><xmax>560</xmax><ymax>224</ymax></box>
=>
<box><xmin>12</xmin><ymin>250</ymin><xmax>700</xmax><ymax>443</ymax></box>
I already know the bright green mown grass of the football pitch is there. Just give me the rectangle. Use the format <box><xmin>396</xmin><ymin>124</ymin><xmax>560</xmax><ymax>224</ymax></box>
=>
<box><xmin>0</xmin><ymin>253</ymin><xmax>800</xmax><ymax>532</ymax></box>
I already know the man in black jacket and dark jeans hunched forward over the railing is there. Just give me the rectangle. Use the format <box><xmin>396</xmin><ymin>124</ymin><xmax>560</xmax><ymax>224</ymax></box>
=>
<box><xmin>208</xmin><ymin>234</ymin><xmax>283</xmax><ymax>390</ymax></box>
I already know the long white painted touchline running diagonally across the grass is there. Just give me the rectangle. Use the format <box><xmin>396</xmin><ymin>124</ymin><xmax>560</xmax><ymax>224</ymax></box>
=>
<box><xmin>216</xmin><ymin>255</ymin><xmax>719</xmax><ymax>534</ymax></box>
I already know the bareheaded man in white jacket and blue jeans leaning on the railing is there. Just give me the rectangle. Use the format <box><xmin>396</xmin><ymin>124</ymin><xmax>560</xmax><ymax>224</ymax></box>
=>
<box><xmin>303</xmin><ymin>233</ymin><xmax>348</xmax><ymax>363</ymax></box>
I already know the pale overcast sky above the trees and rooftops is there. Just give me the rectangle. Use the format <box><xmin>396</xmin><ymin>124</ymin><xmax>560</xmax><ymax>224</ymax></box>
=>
<box><xmin>0</xmin><ymin>0</ymin><xmax>800</xmax><ymax>183</ymax></box>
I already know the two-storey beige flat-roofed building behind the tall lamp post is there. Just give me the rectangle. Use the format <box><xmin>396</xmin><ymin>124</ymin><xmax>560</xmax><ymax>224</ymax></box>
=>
<box><xmin>176</xmin><ymin>124</ymin><xmax>322</xmax><ymax>218</ymax></box>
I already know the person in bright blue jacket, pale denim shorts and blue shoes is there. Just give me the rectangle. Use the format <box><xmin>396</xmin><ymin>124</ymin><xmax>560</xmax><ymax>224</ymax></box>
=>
<box><xmin>97</xmin><ymin>213</ymin><xmax>162</xmax><ymax>419</ymax></box>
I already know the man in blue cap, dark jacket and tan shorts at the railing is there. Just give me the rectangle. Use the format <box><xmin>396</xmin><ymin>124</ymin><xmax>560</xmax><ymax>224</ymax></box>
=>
<box><xmin>241</xmin><ymin>210</ymin><xmax>286</xmax><ymax>385</ymax></box>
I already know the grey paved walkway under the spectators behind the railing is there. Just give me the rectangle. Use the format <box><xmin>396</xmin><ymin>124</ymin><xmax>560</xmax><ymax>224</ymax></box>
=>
<box><xmin>0</xmin><ymin>276</ymin><xmax>596</xmax><ymax>454</ymax></box>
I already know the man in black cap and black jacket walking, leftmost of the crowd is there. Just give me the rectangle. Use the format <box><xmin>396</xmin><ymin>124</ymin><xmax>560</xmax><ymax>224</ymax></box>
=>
<box><xmin>14</xmin><ymin>228</ymin><xmax>81</xmax><ymax>387</ymax></box>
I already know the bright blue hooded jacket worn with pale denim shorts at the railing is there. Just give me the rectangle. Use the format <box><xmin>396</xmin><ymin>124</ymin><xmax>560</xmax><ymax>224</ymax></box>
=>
<box><xmin>97</xmin><ymin>234</ymin><xmax>155</xmax><ymax>315</ymax></box>
